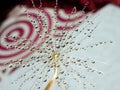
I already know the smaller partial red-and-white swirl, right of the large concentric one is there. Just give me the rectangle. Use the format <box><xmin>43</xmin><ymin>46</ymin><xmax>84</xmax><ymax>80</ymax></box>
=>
<box><xmin>57</xmin><ymin>8</ymin><xmax>86</xmax><ymax>30</ymax></box>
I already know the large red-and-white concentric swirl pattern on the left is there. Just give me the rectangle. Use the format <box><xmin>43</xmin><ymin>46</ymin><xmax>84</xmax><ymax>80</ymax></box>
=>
<box><xmin>0</xmin><ymin>6</ymin><xmax>52</xmax><ymax>65</ymax></box>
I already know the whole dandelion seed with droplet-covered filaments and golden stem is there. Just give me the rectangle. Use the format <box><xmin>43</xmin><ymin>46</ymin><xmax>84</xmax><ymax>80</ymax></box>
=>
<box><xmin>0</xmin><ymin>0</ymin><xmax>112</xmax><ymax>90</ymax></box>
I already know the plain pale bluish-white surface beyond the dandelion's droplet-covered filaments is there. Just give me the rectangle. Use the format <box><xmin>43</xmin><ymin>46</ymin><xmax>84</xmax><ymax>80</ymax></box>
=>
<box><xmin>0</xmin><ymin>5</ymin><xmax>120</xmax><ymax>90</ymax></box>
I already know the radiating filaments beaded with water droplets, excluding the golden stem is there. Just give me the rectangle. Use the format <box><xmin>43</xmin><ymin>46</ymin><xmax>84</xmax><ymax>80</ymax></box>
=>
<box><xmin>0</xmin><ymin>0</ymin><xmax>112</xmax><ymax>90</ymax></box>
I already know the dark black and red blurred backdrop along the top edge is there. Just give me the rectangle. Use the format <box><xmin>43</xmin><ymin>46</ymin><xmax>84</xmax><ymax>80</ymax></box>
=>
<box><xmin>0</xmin><ymin>0</ymin><xmax>120</xmax><ymax>24</ymax></box>
